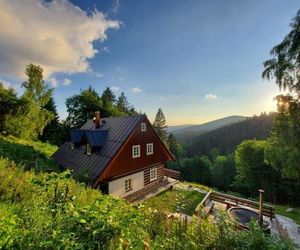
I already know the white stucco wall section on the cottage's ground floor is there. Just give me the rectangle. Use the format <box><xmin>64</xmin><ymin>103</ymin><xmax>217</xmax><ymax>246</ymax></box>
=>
<box><xmin>108</xmin><ymin>171</ymin><xmax>144</xmax><ymax>197</ymax></box>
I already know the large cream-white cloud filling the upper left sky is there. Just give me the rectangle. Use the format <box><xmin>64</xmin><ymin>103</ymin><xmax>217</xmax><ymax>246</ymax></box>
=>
<box><xmin>0</xmin><ymin>0</ymin><xmax>120</xmax><ymax>78</ymax></box>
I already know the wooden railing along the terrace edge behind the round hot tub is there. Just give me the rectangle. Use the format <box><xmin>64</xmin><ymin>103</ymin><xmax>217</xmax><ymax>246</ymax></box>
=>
<box><xmin>196</xmin><ymin>191</ymin><xmax>275</xmax><ymax>219</ymax></box>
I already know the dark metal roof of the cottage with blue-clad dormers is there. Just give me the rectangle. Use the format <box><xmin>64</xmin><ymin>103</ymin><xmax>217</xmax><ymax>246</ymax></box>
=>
<box><xmin>52</xmin><ymin>115</ymin><xmax>143</xmax><ymax>182</ymax></box>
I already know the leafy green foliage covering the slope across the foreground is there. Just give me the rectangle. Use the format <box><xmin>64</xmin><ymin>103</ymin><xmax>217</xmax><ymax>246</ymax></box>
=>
<box><xmin>0</xmin><ymin>159</ymin><xmax>293</xmax><ymax>249</ymax></box>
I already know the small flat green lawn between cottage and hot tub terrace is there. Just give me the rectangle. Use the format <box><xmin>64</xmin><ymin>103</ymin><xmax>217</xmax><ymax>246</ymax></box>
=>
<box><xmin>143</xmin><ymin>189</ymin><xmax>205</xmax><ymax>215</ymax></box>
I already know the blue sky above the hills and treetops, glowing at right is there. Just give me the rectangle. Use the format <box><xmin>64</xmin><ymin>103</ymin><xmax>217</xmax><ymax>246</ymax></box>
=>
<box><xmin>0</xmin><ymin>0</ymin><xmax>300</xmax><ymax>125</ymax></box>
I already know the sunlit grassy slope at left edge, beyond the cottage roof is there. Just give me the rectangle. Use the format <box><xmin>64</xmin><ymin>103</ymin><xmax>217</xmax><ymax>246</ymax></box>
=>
<box><xmin>0</xmin><ymin>136</ymin><xmax>57</xmax><ymax>170</ymax></box>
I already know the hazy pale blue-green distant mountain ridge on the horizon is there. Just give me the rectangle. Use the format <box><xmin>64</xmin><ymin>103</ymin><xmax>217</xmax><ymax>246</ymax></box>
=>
<box><xmin>169</xmin><ymin>115</ymin><xmax>248</xmax><ymax>140</ymax></box>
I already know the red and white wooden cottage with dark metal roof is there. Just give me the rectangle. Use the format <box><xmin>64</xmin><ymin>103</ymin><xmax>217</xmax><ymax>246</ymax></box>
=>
<box><xmin>53</xmin><ymin>112</ymin><xmax>173</xmax><ymax>201</ymax></box>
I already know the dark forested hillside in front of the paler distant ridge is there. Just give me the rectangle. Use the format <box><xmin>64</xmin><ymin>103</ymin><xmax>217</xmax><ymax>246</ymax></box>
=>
<box><xmin>182</xmin><ymin>113</ymin><xmax>274</xmax><ymax>156</ymax></box>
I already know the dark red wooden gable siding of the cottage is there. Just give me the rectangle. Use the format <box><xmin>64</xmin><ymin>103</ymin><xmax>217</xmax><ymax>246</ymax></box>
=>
<box><xmin>96</xmin><ymin>117</ymin><xmax>173</xmax><ymax>185</ymax></box>
